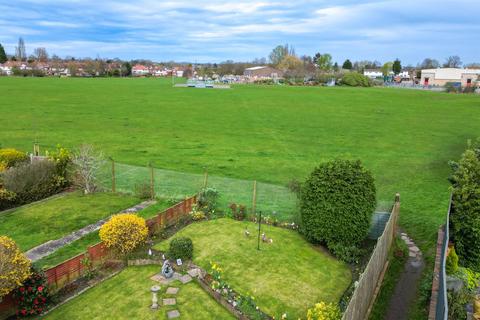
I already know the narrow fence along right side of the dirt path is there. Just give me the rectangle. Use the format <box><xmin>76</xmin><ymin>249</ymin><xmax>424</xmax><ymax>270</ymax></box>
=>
<box><xmin>428</xmin><ymin>197</ymin><xmax>452</xmax><ymax>320</ymax></box>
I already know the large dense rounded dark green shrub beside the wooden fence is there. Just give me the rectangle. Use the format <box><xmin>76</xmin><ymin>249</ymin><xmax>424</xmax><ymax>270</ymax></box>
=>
<box><xmin>300</xmin><ymin>160</ymin><xmax>376</xmax><ymax>247</ymax></box>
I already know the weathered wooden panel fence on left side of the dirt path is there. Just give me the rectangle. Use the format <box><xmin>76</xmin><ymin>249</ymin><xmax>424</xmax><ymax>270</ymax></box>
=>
<box><xmin>342</xmin><ymin>194</ymin><xmax>400</xmax><ymax>320</ymax></box>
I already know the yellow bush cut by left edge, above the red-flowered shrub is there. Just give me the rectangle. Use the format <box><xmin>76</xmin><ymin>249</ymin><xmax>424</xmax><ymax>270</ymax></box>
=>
<box><xmin>0</xmin><ymin>236</ymin><xmax>31</xmax><ymax>298</ymax></box>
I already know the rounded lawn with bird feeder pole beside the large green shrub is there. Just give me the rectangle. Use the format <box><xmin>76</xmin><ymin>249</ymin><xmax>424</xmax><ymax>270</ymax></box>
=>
<box><xmin>155</xmin><ymin>218</ymin><xmax>351</xmax><ymax>319</ymax></box>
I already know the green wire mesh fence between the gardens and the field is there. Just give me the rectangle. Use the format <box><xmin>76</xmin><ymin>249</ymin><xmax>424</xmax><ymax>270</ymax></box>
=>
<box><xmin>99</xmin><ymin>163</ymin><xmax>297</xmax><ymax>221</ymax></box>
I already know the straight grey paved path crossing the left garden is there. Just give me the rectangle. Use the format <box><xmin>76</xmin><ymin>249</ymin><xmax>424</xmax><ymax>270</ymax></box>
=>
<box><xmin>26</xmin><ymin>200</ymin><xmax>156</xmax><ymax>262</ymax></box>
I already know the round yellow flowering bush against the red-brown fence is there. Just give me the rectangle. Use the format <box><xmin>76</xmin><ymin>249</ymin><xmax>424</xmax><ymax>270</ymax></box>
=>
<box><xmin>99</xmin><ymin>213</ymin><xmax>148</xmax><ymax>254</ymax></box>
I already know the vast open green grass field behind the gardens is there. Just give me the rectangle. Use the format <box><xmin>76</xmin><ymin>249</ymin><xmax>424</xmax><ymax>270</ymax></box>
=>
<box><xmin>0</xmin><ymin>77</ymin><xmax>480</xmax><ymax>256</ymax></box>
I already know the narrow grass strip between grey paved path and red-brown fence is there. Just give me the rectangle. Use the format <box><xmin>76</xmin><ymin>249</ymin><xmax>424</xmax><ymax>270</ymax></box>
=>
<box><xmin>35</xmin><ymin>199</ymin><xmax>171</xmax><ymax>269</ymax></box>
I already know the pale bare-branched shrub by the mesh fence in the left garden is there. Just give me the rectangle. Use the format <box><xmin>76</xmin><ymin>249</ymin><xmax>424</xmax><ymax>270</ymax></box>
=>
<box><xmin>72</xmin><ymin>144</ymin><xmax>105</xmax><ymax>194</ymax></box>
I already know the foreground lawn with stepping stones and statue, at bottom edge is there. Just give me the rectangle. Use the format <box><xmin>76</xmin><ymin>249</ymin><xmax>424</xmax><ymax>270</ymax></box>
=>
<box><xmin>42</xmin><ymin>266</ymin><xmax>234</xmax><ymax>320</ymax></box>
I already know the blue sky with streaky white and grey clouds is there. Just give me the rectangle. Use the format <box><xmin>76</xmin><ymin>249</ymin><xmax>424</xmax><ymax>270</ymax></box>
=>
<box><xmin>0</xmin><ymin>0</ymin><xmax>480</xmax><ymax>65</ymax></box>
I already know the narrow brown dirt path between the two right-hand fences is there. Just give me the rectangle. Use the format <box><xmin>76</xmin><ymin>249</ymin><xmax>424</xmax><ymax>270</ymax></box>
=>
<box><xmin>385</xmin><ymin>233</ymin><xmax>425</xmax><ymax>320</ymax></box>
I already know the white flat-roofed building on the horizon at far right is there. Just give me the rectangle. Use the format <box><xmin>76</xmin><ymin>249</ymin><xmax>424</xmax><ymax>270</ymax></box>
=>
<box><xmin>420</xmin><ymin>68</ymin><xmax>480</xmax><ymax>87</ymax></box>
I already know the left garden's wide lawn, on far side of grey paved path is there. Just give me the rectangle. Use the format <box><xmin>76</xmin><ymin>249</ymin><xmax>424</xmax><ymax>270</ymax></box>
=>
<box><xmin>0</xmin><ymin>192</ymin><xmax>141</xmax><ymax>251</ymax></box>
